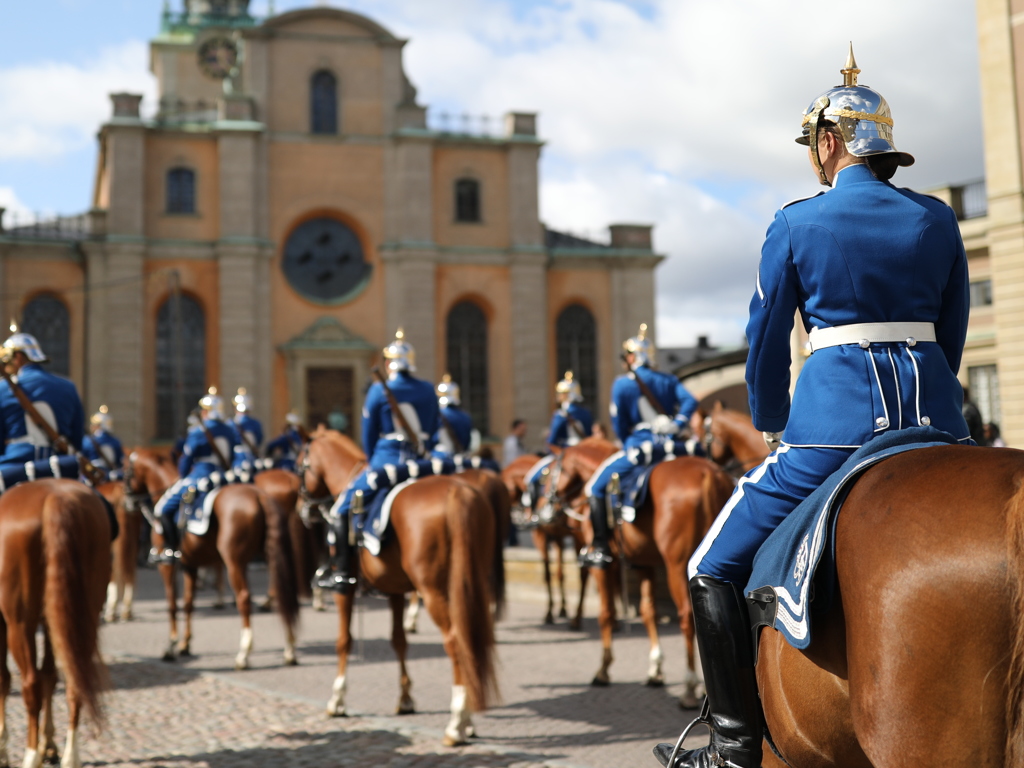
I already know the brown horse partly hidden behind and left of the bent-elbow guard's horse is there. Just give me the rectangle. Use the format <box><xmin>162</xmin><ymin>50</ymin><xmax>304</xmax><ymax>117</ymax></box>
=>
<box><xmin>502</xmin><ymin>454</ymin><xmax>595</xmax><ymax>630</ymax></box>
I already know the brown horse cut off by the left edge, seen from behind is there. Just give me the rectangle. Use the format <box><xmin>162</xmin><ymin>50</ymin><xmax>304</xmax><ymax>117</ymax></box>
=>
<box><xmin>0</xmin><ymin>479</ymin><xmax>111</xmax><ymax>768</ymax></box>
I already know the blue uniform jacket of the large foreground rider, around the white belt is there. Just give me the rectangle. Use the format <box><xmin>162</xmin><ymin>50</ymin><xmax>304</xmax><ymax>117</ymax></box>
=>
<box><xmin>746</xmin><ymin>165</ymin><xmax>970</xmax><ymax>446</ymax></box>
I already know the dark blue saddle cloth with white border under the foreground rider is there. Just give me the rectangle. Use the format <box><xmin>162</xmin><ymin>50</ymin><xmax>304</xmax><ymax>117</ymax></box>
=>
<box><xmin>746</xmin><ymin>427</ymin><xmax>957</xmax><ymax>648</ymax></box>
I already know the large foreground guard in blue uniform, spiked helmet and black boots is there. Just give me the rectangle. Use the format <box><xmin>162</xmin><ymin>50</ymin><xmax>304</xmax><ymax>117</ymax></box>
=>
<box><xmin>654</xmin><ymin>46</ymin><xmax>971</xmax><ymax>768</ymax></box>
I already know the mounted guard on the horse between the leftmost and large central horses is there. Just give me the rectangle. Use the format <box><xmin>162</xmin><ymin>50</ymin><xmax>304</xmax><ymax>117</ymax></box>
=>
<box><xmin>150</xmin><ymin>387</ymin><xmax>239</xmax><ymax>563</ymax></box>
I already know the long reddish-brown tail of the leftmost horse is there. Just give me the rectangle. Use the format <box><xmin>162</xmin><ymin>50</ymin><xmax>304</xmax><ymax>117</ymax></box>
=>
<box><xmin>43</xmin><ymin>487</ymin><xmax>111</xmax><ymax>725</ymax></box>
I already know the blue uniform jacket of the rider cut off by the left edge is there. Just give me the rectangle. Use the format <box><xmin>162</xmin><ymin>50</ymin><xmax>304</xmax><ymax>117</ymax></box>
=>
<box><xmin>0</xmin><ymin>362</ymin><xmax>85</xmax><ymax>463</ymax></box>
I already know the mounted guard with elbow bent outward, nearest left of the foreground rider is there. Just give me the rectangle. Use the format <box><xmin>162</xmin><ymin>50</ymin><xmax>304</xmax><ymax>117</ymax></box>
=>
<box><xmin>580</xmin><ymin>324</ymin><xmax>697</xmax><ymax>568</ymax></box>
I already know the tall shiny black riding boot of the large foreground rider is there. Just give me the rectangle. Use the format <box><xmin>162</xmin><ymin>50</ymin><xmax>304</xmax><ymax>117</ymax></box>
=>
<box><xmin>654</xmin><ymin>575</ymin><xmax>764</xmax><ymax>768</ymax></box>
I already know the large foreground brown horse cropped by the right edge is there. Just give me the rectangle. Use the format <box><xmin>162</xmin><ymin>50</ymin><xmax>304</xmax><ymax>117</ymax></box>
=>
<box><xmin>757</xmin><ymin>446</ymin><xmax>1024</xmax><ymax>768</ymax></box>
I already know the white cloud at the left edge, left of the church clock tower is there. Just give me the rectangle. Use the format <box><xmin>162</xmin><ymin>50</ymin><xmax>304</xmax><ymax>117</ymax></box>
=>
<box><xmin>0</xmin><ymin>41</ymin><xmax>156</xmax><ymax>162</ymax></box>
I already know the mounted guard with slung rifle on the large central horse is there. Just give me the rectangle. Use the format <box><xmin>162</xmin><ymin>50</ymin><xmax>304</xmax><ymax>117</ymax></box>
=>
<box><xmin>314</xmin><ymin>328</ymin><xmax>440</xmax><ymax>592</ymax></box>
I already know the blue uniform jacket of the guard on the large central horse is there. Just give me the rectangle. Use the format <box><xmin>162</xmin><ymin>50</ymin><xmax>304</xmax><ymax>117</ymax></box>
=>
<box><xmin>362</xmin><ymin>371</ymin><xmax>440</xmax><ymax>469</ymax></box>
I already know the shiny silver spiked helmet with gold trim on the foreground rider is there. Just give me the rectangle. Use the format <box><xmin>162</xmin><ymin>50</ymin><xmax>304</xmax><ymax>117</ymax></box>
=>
<box><xmin>797</xmin><ymin>43</ymin><xmax>913</xmax><ymax>186</ymax></box>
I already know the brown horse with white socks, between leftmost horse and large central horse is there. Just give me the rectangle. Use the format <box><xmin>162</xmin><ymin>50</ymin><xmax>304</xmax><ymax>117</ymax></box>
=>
<box><xmin>125</xmin><ymin>449</ymin><xmax>299</xmax><ymax>670</ymax></box>
